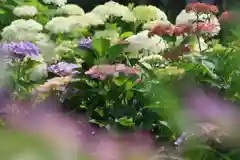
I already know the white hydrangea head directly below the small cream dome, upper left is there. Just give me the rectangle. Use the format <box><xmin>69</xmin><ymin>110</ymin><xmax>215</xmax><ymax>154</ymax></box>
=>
<box><xmin>45</xmin><ymin>17</ymin><xmax>77</xmax><ymax>34</ymax></box>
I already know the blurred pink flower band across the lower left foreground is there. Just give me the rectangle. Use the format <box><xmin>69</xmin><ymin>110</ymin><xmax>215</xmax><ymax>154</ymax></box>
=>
<box><xmin>3</xmin><ymin>101</ymin><xmax>158</xmax><ymax>160</ymax></box>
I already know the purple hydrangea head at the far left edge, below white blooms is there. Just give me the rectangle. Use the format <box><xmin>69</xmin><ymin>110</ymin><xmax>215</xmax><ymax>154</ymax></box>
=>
<box><xmin>2</xmin><ymin>42</ymin><xmax>40</xmax><ymax>57</ymax></box>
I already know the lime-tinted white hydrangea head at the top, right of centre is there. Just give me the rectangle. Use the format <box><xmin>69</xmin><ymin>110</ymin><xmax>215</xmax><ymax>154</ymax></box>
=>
<box><xmin>133</xmin><ymin>5</ymin><xmax>168</xmax><ymax>21</ymax></box>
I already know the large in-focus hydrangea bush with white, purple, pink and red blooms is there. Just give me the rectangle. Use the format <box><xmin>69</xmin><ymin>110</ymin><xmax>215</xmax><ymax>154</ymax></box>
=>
<box><xmin>0</xmin><ymin>0</ymin><xmax>240</xmax><ymax>159</ymax></box>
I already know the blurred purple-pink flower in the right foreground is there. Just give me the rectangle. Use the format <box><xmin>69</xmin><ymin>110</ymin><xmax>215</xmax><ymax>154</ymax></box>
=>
<box><xmin>179</xmin><ymin>89</ymin><xmax>240</xmax><ymax>143</ymax></box>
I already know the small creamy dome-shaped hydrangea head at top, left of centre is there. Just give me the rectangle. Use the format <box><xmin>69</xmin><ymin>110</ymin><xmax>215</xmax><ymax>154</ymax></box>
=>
<box><xmin>57</xmin><ymin>4</ymin><xmax>85</xmax><ymax>15</ymax></box>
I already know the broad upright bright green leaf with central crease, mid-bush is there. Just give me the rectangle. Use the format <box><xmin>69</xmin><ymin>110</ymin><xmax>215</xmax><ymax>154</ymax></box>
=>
<box><xmin>92</xmin><ymin>38</ymin><xmax>111</xmax><ymax>57</ymax></box>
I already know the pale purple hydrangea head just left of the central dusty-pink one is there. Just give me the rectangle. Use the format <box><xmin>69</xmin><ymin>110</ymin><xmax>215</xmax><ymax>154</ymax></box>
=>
<box><xmin>48</xmin><ymin>62</ymin><xmax>79</xmax><ymax>76</ymax></box>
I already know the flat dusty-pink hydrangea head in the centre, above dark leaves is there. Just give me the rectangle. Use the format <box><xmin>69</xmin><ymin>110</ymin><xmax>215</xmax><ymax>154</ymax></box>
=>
<box><xmin>85</xmin><ymin>64</ymin><xmax>140</xmax><ymax>80</ymax></box>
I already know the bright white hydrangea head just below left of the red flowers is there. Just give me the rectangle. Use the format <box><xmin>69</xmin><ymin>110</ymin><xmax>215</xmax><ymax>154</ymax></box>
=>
<box><xmin>125</xmin><ymin>30</ymin><xmax>168</xmax><ymax>54</ymax></box>
